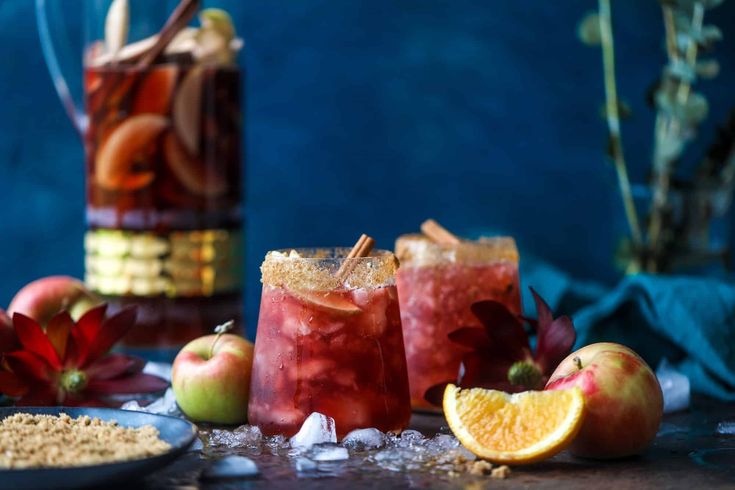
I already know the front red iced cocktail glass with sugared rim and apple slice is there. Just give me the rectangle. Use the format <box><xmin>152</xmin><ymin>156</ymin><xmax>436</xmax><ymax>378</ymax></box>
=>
<box><xmin>248</xmin><ymin>249</ymin><xmax>411</xmax><ymax>437</ymax></box>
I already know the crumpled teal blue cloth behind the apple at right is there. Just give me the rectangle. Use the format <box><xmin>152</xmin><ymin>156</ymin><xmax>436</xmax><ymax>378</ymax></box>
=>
<box><xmin>524</xmin><ymin>260</ymin><xmax>735</xmax><ymax>401</ymax></box>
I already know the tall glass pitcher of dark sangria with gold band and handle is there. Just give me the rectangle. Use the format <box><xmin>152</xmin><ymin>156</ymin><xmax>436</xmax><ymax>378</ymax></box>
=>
<box><xmin>36</xmin><ymin>0</ymin><xmax>243</xmax><ymax>360</ymax></box>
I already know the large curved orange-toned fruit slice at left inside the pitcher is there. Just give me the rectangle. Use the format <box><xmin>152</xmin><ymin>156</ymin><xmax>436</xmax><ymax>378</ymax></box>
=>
<box><xmin>95</xmin><ymin>114</ymin><xmax>168</xmax><ymax>191</ymax></box>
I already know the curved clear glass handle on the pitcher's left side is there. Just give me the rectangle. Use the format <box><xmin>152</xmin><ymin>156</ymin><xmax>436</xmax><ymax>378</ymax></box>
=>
<box><xmin>36</xmin><ymin>0</ymin><xmax>87</xmax><ymax>136</ymax></box>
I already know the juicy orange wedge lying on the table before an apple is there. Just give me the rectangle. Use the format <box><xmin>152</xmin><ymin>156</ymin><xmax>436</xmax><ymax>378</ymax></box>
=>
<box><xmin>443</xmin><ymin>384</ymin><xmax>584</xmax><ymax>464</ymax></box>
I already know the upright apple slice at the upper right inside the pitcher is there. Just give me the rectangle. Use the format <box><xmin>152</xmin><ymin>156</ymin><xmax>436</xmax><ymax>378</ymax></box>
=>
<box><xmin>173</xmin><ymin>66</ymin><xmax>204</xmax><ymax>155</ymax></box>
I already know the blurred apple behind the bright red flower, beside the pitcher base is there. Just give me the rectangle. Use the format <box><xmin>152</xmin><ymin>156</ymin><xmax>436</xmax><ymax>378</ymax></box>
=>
<box><xmin>8</xmin><ymin>276</ymin><xmax>101</xmax><ymax>325</ymax></box>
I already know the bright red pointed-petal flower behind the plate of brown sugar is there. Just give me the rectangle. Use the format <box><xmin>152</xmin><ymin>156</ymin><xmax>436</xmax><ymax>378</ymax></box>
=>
<box><xmin>0</xmin><ymin>305</ymin><xmax>168</xmax><ymax>406</ymax></box>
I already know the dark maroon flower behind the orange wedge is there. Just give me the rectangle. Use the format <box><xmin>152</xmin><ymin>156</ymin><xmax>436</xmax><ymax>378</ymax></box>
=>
<box><xmin>425</xmin><ymin>288</ymin><xmax>577</xmax><ymax>405</ymax></box>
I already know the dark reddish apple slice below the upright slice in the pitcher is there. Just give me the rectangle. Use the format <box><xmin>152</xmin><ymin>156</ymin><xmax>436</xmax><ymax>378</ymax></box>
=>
<box><xmin>163</xmin><ymin>131</ymin><xmax>228</xmax><ymax>197</ymax></box>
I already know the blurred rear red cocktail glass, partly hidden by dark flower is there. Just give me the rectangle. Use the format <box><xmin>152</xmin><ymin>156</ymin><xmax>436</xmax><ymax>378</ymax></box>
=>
<box><xmin>396</xmin><ymin>235</ymin><xmax>521</xmax><ymax>410</ymax></box>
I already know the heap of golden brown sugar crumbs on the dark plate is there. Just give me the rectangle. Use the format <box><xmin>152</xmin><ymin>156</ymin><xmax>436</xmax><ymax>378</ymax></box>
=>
<box><xmin>0</xmin><ymin>413</ymin><xmax>171</xmax><ymax>469</ymax></box>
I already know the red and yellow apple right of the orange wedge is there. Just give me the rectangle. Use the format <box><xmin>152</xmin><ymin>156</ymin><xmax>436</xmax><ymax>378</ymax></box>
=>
<box><xmin>545</xmin><ymin>342</ymin><xmax>663</xmax><ymax>459</ymax></box>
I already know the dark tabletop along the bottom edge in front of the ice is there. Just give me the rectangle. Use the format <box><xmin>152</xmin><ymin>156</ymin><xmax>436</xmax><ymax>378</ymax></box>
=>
<box><xmin>134</xmin><ymin>398</ymin><xmax>735</xmax><ymax>490</ymax></box>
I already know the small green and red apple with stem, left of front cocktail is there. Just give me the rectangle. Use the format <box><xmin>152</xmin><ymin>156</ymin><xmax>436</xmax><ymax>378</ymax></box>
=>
<box><xmin>171</xmin><ymin>334</ymin><xmax>253</xmax><ymax>424</ymax></box>
